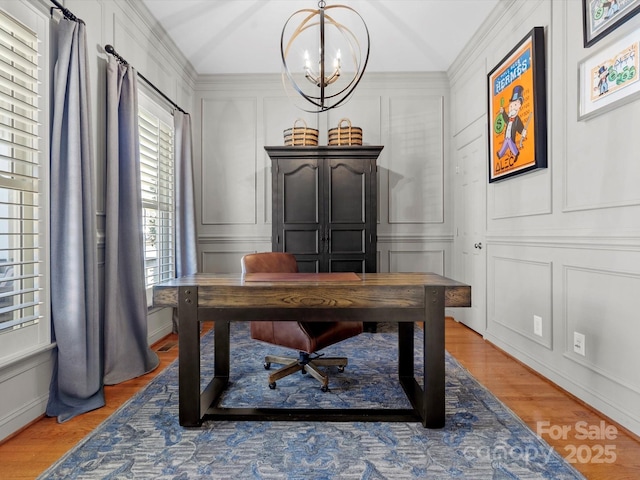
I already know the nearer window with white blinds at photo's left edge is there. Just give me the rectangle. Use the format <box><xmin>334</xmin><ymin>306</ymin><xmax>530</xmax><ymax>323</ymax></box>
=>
<box><xmin>0</xmin><ymin>2</ymin><xmax>50</xmax><ymax>363</ymax></box>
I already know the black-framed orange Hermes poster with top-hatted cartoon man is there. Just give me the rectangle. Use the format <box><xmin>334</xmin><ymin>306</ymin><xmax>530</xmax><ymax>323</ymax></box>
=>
<box><xmin>487</xmin><ymin>27</ymin><xmax>547</xmax><ymax>182</ymax></box>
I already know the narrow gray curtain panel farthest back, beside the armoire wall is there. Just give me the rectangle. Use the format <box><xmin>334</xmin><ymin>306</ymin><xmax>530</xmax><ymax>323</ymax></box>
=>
<box><xmin>173</xmin><ymin>110</ymin><xmax>198</xmax><ymax>333</ymax></box>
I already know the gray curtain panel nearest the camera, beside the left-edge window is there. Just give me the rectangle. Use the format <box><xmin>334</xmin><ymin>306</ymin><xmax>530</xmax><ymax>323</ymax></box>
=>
<box><xmin>46</xmin><ymin>20</ymin><xmax>104</xmax><ymax>422</ymax></box>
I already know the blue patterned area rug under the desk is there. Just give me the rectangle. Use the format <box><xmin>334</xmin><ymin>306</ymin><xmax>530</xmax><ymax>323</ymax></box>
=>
<box><xmin>39</xmin><ymin>324</ymin><xmax>584</xmax><ymax>480</ymax></box>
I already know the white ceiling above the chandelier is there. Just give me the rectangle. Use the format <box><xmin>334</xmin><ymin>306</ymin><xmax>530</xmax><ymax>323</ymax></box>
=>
<box><xmin>142</xmin><ymin>0</ymin><xmax>500</xmax><ymax>74</ymax></box>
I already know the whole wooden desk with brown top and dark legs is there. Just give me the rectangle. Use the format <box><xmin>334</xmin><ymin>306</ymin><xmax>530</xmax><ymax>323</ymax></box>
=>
<box><xmin>153</xmin><ymin>273</ymin><xmax>471</xmax><ymax>428</ymax></box>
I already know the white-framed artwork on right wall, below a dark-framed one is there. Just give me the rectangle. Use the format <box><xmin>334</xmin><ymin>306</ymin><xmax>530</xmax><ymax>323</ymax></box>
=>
<box><xmin>578</xmin><ymin>30</ymin><xmax>640</xmax><ymax>120</ymax></box>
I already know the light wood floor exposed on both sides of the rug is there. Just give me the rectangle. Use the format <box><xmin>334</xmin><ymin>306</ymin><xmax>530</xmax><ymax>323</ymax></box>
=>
<box><xmin>0</xmin><ymin>319</ymin><xmax>640</xmax><ymax>480</ymax></box>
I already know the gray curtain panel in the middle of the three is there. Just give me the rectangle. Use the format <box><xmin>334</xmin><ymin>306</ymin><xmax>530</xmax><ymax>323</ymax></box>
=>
<box><xmin>104</xmin><ymin>56</ymin><xmax>159</xmax><ymax>385</ymax></box>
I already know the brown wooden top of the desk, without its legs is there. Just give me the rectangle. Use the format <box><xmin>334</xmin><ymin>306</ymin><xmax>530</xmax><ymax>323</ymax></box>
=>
<box><xmin>153</xmin><ymin>273</ymin><xmax>471</xmax><ymax>308</ymax></box>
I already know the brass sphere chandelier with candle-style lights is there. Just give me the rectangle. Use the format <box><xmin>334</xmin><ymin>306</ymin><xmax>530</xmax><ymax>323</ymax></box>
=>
<box><xmin>280</xmin><ymin>0</ymin><xmax>370</xmax><ymax>113</ymax></box>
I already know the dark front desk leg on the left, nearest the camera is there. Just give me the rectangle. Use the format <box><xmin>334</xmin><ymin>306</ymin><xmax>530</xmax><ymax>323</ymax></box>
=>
<box><xmin>178</xmin><ymin>287</ymin><xmax>201</xmax><ymax>427</ymax></box>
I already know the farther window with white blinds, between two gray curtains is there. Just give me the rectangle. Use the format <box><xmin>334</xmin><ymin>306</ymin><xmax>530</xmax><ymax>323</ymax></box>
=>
<box><xmin>138</xmin><ymin>95</ymin><xmax>175</xmax><ymax>299</ymax></box>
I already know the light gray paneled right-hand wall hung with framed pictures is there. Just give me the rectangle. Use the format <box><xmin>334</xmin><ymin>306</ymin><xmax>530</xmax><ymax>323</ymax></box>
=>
<box><xmin>451</xmin><ymin>0</ymin><xmax>640</xmax><ymax>433</ymax></box>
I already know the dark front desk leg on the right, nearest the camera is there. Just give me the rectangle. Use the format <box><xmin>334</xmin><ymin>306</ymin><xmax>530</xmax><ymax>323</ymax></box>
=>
<box><xmin>423</xmin><ymin>287</ymin><xmax>445</xmax><ymax>428</ymax></box>
